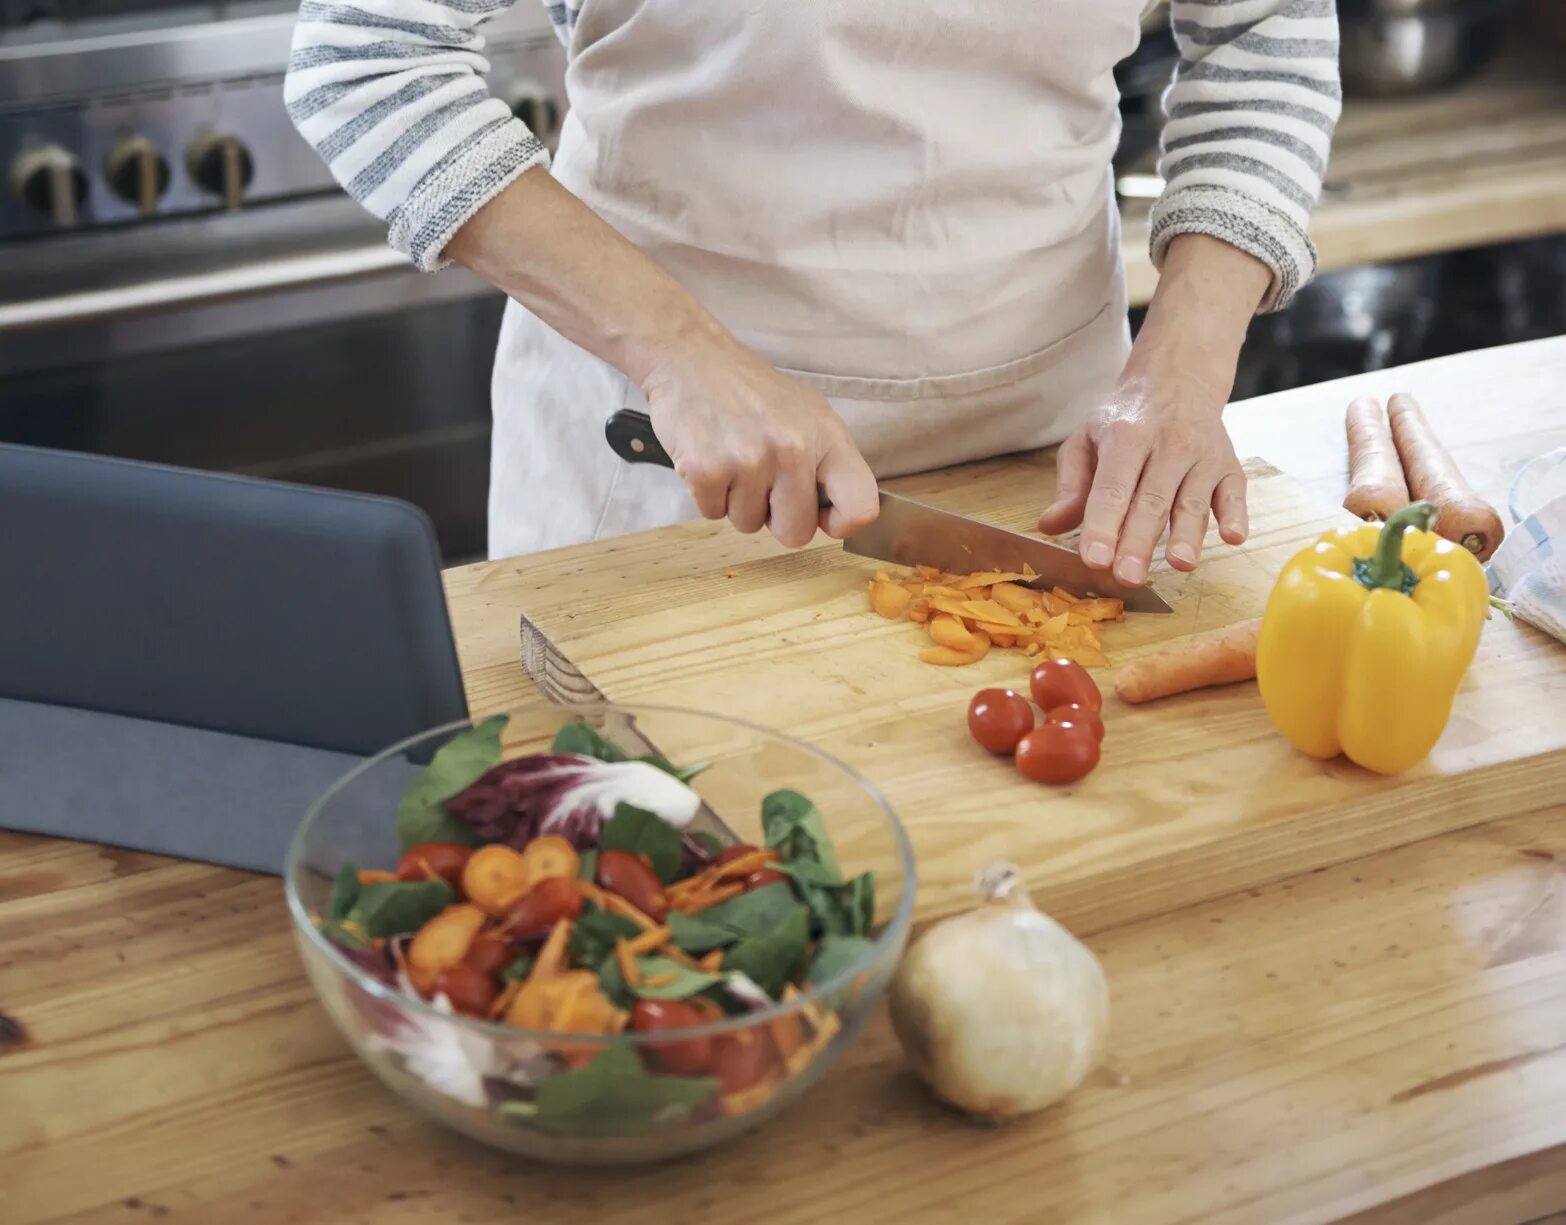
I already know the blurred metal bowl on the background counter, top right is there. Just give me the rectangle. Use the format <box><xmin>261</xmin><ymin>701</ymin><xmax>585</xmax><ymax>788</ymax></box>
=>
<box><xmin>1339</xmin><ymin>0</ymin><xmax>1511</xmax><ymax>97</ymax></box>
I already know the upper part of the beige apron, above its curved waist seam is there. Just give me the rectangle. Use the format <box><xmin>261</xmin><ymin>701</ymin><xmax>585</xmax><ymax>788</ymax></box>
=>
<box><xmin>554</xmin><ymin>0</ymin><xmax>1143</xmax><ymax>379</ymax></box>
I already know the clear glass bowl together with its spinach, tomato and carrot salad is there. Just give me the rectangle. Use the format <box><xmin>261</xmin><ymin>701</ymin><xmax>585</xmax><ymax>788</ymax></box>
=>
<box><xmin>285</xmin><ymin>706</ymin><xmax>913</xmax><ymax>1162</ymax></box>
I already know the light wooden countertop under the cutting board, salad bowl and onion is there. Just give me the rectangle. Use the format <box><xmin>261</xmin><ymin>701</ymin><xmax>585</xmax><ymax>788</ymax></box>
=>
<box><xmin>0</xmin><ymin>338</ymin><xmax>1566</xmax><ymax>1225</ymax></box>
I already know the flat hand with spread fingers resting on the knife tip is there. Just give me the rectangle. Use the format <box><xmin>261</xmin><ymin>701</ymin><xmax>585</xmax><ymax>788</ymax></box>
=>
<box><xmin>1038</xmin><ymin>357</ymin><xmax>1250</xmax><ymax>587</ymax></box>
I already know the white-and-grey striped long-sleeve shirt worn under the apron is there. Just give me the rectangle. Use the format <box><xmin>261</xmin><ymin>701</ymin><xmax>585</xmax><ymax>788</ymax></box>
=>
<box><xmin>285</xmin><ymin>0</ymin><xmax>1340</xmax><ymax>309</ymax></box>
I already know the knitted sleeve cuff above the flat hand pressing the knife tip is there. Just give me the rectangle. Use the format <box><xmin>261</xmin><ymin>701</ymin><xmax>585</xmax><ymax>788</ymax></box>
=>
<box><xmin>1149</xmin><ymin>186</ymin><xmax>1315</xmax><ymax>313</ymax></box>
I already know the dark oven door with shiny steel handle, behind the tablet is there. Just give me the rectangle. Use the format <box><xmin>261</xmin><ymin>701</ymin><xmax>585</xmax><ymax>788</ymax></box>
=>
<box><xmin>0</xmin><ymin>196</ymin><xmax>504</xmax><ymax>562</ymax></box>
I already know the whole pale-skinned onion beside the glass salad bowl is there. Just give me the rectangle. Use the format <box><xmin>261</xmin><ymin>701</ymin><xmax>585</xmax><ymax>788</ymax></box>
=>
<box><xmin>891</xmin><ymin>863</ymin><xmax>1109</xmax><ymax>1120</ymax></box>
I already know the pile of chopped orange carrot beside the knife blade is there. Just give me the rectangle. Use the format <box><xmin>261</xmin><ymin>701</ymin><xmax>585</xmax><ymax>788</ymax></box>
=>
<box><xmin>869</xmin><ymin>566</ymin><xmax>1126</xmax><ymax>667</ymax></box>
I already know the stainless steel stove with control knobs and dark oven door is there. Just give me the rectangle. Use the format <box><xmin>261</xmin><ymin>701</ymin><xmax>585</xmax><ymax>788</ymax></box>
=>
<box><xmin>0</xmin><ymin>0</ymin><xmax>564</xmax><ymax>558</ymax></box>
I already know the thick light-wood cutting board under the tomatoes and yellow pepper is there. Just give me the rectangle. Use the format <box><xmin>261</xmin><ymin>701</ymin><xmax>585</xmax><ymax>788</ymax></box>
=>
<box><xmin>510</xmin><ymin>459</ymin><xmax>1566</xmax><ymax>930</ymax></box>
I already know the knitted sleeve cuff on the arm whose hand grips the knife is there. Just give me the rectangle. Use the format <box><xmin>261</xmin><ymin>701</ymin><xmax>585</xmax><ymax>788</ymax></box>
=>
<box><xmin>388</xmin><ymin>121</ymin><xmax>550</xmax><ymax>273</ymax></box>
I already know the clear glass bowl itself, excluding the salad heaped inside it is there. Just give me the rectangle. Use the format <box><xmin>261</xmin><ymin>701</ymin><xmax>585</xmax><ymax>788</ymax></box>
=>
<box><xmin>285</xmin><ymin>705</ymin><xmax>915</xmax><ymax>1164</ymax></box>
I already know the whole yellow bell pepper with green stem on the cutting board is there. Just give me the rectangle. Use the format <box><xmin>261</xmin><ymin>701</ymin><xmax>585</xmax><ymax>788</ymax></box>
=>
<box><xmin>1256</xmin><ymin>501</ymin><xmax>1489</xmax><ymax>774</ymax></box>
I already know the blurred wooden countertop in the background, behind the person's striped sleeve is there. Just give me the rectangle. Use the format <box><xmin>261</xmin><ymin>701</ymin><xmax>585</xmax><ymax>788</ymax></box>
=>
<box><xmin>1121</xmin><ymin>47</ymin><xmax>1566</xmax><ymax>305</ymax></box>
